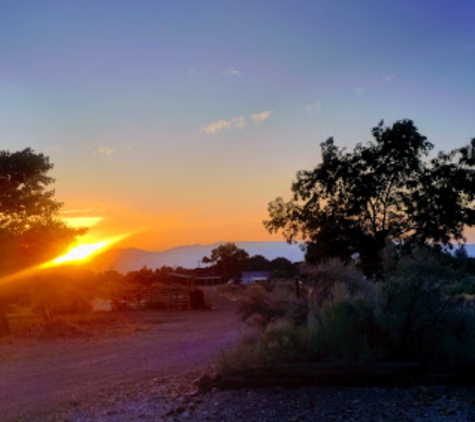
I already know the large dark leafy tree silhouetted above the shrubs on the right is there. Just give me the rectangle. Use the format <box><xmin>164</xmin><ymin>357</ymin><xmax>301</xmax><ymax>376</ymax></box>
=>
<box><xmin>264</xmin><ymin>120</ymin><xmax>475</xmax><ymax>275</ymax></box>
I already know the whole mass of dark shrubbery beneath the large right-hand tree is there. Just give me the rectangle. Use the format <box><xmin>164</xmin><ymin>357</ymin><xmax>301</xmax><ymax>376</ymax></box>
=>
<box><xmin>222</xmin><ymin>249</ymin><xmax>475</xmax><ymax>370</ymax></box>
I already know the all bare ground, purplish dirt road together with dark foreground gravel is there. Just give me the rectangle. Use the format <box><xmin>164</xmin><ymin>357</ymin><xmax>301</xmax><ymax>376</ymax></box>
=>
<box><xmin>0</xmin><ymin>291</ymin><xmax>475</xmax><ymax>422</ymax></box>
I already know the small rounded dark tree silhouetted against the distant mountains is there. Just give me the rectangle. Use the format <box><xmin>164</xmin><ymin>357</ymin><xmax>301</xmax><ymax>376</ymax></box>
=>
<box><xmin>203</xmin><ymin>243</ymin><xmax>249</xmax><ymax>280</ymax></box>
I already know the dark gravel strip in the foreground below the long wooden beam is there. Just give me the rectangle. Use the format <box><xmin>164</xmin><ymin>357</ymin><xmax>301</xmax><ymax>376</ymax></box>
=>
<box><xmin>19</xmin><ymin>368</ymin><xmax>475</xmax><ymax>422</ymax></box>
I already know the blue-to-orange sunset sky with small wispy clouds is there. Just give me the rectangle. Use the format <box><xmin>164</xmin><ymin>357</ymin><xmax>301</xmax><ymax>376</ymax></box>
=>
<box><xmin>0</xmin><ymin>0</ymin><xmax>475</xmax><ymax>250</ymax></box>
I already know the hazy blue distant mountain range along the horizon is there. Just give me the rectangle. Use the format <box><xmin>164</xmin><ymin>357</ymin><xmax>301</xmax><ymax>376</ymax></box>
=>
<box><xmin>89</xmin><ymin>242</ymin><xmax>304</xmax><ymax>273</ymax></box>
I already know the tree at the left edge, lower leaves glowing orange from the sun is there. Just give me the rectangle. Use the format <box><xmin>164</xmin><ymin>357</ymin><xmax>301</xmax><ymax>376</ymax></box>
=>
<box><xmin>0</xmin><ymin>148</ymin><xmax>85</xmax><ymax>335</ymax></box>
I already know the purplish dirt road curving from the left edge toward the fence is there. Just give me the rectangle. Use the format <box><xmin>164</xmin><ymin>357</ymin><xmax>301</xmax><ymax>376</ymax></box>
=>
<box><xmin>0</xmin><ymin>288</ymin><xmax>242</xmax><ymax>421</ymax></box>
